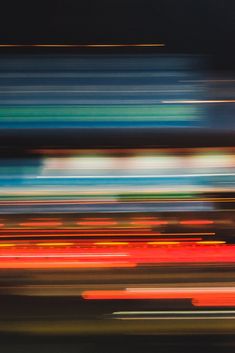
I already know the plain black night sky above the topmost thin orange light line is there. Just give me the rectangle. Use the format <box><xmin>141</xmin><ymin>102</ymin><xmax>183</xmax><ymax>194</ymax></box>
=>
<box><xmin>0</xmin><ymin>0</ymin><xmax>235</xmax><ymax>65</ymax></box>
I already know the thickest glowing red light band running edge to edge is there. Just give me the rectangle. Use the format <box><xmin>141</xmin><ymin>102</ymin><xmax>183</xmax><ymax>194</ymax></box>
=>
<box><xmin>0</xmin><ymin>240</ymin><xmax>235</xmax><ymax>268</ymax></box>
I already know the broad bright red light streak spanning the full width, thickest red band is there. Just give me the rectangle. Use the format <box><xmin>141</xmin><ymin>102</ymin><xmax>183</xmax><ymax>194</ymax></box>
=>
<box><xmin>0</xmin><ymin>243</ymin><xmax>232</xmax><ymax>269</ymax></box>
